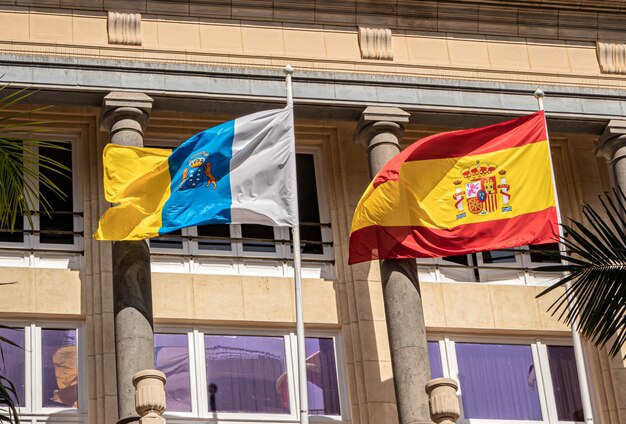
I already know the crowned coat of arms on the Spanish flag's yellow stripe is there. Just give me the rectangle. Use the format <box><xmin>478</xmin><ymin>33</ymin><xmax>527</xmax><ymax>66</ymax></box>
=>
<box><xmin>452</xmin><ymin>160</ymin><xmax>513</xmax><ymax>219</ymax></box>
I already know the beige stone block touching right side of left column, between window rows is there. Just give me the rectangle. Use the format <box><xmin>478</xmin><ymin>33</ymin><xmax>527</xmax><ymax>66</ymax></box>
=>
<box><xmin>152</xmin><ymin>273</ymin><xmax>195</xmax><ymax>319</ymax></box>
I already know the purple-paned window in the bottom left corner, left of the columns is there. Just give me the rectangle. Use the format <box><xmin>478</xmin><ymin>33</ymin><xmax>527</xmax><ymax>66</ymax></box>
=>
<box><xmin>0</xmin><ymin>323</ymin><xmax>86</xmax><ymax>422</ymax></box>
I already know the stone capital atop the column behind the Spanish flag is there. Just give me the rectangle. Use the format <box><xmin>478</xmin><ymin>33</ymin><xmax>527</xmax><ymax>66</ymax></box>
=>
<box><xmin>354</xmin><ymin>106</ymin><xmax>411</xmax><ymax>148</ymax></box>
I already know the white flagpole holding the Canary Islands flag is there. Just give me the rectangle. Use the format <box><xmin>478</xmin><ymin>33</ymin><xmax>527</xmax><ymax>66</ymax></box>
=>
<box><xmin>284</xmin><ymin>65</ymin><xmax>309</xmax><ymax>424</ymax></box>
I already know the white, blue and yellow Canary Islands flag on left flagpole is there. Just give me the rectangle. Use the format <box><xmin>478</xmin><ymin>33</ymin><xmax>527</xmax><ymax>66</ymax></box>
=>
<box><xmin>94</xmin><ymin>106</ymin><xmax>298</xmax><ymax>240</ymax></box>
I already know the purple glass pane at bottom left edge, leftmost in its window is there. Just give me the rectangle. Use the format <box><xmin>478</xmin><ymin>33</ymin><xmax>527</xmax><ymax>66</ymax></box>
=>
<box><xmin>0</xmin><ymin>328</ymin><xmax>26</xmax><ymax>406</ymax></box>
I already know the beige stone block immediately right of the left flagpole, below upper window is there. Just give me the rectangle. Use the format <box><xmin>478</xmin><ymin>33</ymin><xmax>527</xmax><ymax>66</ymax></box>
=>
<box><xmin>302</xmin><ymin>279</ymin><xmax>339</xmax><ymax>324</ymax></box>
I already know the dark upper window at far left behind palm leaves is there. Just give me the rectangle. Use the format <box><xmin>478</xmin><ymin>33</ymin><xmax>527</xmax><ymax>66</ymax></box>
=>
<box><xmin>0</xmin><ymin>135</ymin><xmax>82</xmax><ymax>268</ymax></box>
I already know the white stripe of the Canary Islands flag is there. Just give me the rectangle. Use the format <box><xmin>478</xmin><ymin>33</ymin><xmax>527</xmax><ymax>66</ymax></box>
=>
<box><xmin>230</xmin><ymin>107</ymin><xmax>298</xmax><ymax>227</ymax></box>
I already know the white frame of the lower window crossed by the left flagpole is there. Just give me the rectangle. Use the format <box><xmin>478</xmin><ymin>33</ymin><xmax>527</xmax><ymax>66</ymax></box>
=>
<box><xmin>154</xmin><ymin>325</ymin><xmax>349</xmax><ymax>423</ymax></box>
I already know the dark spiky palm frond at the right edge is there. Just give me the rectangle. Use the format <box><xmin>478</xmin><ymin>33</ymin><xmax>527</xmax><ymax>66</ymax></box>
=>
<box><xmin>538</xmin><ymin>190</ymin><xmax>626</xmax><ymax>356</ymax></box>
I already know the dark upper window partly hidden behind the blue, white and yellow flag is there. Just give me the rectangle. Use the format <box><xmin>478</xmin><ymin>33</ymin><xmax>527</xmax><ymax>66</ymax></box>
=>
<box><xmin>150</xmin><ymin>150</ymin><xmax>332</xmax><ymax>277</ymax></box>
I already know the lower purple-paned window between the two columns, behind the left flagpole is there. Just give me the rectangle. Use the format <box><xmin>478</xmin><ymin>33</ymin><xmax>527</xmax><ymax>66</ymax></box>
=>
<box><xmin>154</xmin><ymin>331</ymin><xmax>345</xmax><ymax>421</ymax></box>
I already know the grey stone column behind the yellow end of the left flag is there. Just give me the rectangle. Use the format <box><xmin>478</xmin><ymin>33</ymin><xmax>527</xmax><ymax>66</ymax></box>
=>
<box><xmin>101</xmin><ymin>92</ymin><xmax>154</xmax><ymax>424</ymax></box>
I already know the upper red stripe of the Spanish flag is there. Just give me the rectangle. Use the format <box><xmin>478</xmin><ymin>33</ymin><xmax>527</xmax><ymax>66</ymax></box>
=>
<box><xmin>374</xmin><ymin>110</ymin><xmax>548</xmax><ymax>187</ymax></box>
